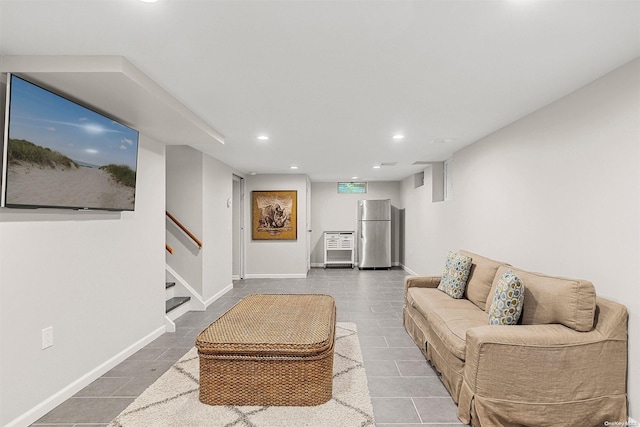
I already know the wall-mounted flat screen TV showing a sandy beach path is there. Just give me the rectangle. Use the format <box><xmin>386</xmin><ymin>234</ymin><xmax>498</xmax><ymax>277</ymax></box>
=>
<box><xmin>0</xmin><ymin>74</ymin><xmax>138</xmax><ymax>211</ymax></box>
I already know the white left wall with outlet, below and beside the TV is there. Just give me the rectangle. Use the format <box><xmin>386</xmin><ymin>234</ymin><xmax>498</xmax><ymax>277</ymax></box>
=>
<box><xmin>0</xmin><ymin>135</ymin><xmax>165</xmax><ymax>425</ymax></box>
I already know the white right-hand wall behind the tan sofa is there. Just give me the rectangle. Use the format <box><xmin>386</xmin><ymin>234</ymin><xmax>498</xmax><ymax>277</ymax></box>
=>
<box><xmin>402</xmin><ymin>60</ymin><xmax>640</xmax><ymax>420</ymax></box>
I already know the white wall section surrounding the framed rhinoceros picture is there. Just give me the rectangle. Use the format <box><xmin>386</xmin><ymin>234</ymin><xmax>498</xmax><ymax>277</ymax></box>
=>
<box><xmin>245</xmin><ymin>175</ymin><xmax>308</xmax><ymax>278</ymax></box>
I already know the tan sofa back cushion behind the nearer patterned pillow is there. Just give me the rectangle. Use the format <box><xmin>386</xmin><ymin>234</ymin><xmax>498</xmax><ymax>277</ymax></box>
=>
<box><xmin>486</xmin><ymin>267</ymin><xmax>596</xmax><ymax>332</ymax></box>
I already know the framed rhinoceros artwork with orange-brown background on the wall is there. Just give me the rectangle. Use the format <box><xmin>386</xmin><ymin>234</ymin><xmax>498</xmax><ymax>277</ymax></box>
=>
<box><xmin>251</xmin><ymin>190</ymin><xmax>298</xmax><ymax>240</ymax></box>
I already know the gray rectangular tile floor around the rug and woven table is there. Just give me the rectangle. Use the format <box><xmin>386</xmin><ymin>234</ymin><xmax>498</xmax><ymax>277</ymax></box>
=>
<box><xmin>33</xmin><ymin>268</ymin><xmax>461</xmax><ymax>427</ymax></box>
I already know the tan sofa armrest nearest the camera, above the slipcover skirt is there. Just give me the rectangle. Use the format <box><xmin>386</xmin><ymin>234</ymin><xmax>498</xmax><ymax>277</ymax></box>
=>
<box><xmin>464</xmin><ymin>324</ymin><xmax>627</xmax><ymax>404</ymax></box>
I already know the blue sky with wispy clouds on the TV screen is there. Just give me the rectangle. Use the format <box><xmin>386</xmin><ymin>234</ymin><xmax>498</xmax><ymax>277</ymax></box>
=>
<box><xmin>9</xmin><ymin>76</ymin><xmax>138</xmax><ymax>170</ymax></box>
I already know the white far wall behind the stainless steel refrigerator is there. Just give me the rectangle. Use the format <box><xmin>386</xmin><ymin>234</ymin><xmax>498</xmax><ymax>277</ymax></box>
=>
<box><xmin>311</xmin><ymin>181</ymin><xmax>401</xmax><ymax>266</ymax></box>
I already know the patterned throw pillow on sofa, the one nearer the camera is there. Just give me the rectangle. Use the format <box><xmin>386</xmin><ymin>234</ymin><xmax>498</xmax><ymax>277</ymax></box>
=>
<box><xmin>489</xmin><ymin>270</ymin><xmax>524</xmax><ymax>325</ymax></box>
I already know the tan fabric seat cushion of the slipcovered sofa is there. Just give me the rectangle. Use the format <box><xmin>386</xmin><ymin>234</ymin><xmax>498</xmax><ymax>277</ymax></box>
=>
<box><xmin>407</xmin><ymin>288</ymin><xmax>488</xmax><ymax>360</ymax></box>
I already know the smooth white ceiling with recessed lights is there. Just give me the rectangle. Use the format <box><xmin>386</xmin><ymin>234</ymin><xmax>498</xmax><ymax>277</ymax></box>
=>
<box><xmin>0</xmin><ymin>0</ymin><xmax>640</xmax><ymax>181</ymax></box>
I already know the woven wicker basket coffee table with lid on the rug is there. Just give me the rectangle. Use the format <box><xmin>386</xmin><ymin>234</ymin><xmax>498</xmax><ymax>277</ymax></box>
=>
<box><xmin>196</xmin><ymin>294</ymin><xmax>336</xmax><ymax>406</ymax></box>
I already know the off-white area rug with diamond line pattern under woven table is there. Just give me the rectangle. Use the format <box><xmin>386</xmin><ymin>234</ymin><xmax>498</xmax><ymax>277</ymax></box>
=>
<box><xmin>109</xmin><ymin>322</ymin><xmax>375</xmax><ymax>427</ymax></box>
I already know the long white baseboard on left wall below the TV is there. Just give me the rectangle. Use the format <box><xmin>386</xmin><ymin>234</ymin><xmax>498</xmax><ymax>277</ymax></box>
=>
<box><xmin>5</xmin><ymin>325</ymin><xmax>165</xmax><ymax>427</ymax></box>
